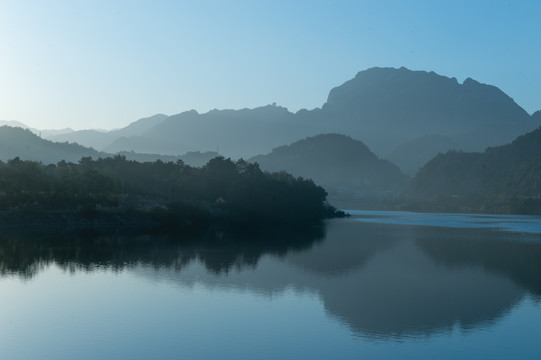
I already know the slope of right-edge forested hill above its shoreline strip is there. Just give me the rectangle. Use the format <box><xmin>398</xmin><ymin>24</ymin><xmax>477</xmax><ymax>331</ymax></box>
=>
<box><xmin>408</xmin><ymin>128</ymin><xmax>541</xmax><ymax>211</ymax></box>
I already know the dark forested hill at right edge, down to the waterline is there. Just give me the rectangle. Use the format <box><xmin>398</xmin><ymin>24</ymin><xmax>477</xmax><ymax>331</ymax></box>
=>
<box><xmin>398</xmin><ymin>128</ymin><xmax>541</xmax><ymax>214</ymax></box>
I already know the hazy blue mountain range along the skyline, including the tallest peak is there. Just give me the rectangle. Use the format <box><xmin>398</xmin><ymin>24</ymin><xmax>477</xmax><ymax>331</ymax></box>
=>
<box><xmin>92</xmin><ymin>68</ymin><xmax>541</xmax><ymax>162</ymax></box>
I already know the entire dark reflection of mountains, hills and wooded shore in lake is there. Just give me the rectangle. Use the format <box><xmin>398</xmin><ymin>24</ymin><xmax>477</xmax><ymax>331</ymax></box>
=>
<box><xmin>0</xmin><ymin>220</ymin><xmax>541</xmax><ymax>337</ymax></box>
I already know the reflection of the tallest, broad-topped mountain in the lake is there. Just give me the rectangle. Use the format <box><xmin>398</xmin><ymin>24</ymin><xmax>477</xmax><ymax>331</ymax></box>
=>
<box><xmin>312</xmin><ymin>226</ymin><xmax>524</xmax><ymax>337</ymax></box>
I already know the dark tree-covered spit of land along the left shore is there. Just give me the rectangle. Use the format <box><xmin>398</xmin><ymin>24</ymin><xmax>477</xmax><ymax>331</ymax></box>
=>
<box><xmin>0</xmin><ymin>156</ymin><xmax>337</xmax><ymax>227</ymax></box>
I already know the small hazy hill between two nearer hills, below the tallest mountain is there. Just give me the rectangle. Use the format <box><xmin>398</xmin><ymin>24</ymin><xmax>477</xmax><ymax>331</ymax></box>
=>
<box><xmin>385</xmin><ymin>135</ymin><xmax>458</xmax><ymax>176</ymax></box>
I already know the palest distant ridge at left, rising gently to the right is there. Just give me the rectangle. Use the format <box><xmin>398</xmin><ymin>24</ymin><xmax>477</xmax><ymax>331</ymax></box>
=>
<box><xmin>46</xmin><ymin>114</ymin><xmax>167</xmax><ymax>150</ymax></box>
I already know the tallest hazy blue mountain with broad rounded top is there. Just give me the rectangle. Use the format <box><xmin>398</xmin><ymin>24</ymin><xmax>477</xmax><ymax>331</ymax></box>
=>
<box><xmin>322</xmin><ymin>68</ymin><xmax>540</xmax><ymax>153</ymax></box>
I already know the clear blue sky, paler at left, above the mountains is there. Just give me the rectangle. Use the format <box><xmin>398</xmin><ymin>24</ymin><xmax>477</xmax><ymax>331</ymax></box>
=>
<box><xmin>0</xmin><ymin>0</ymin><xmax>541</xmax><ymax>129</ymax></box>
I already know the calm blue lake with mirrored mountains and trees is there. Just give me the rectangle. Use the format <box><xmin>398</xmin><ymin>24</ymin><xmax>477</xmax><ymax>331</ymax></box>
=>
<box><xmin>0</xmin><ymin>211</ymin><xmax>541</xmax><ymax>360</ymax></box>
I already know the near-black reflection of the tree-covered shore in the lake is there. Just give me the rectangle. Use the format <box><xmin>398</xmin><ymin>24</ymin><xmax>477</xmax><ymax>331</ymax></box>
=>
<box><xmin>0</xmin><ymin>227</ymin><xmax>323</xmax><ymax>277</ymax></box>
